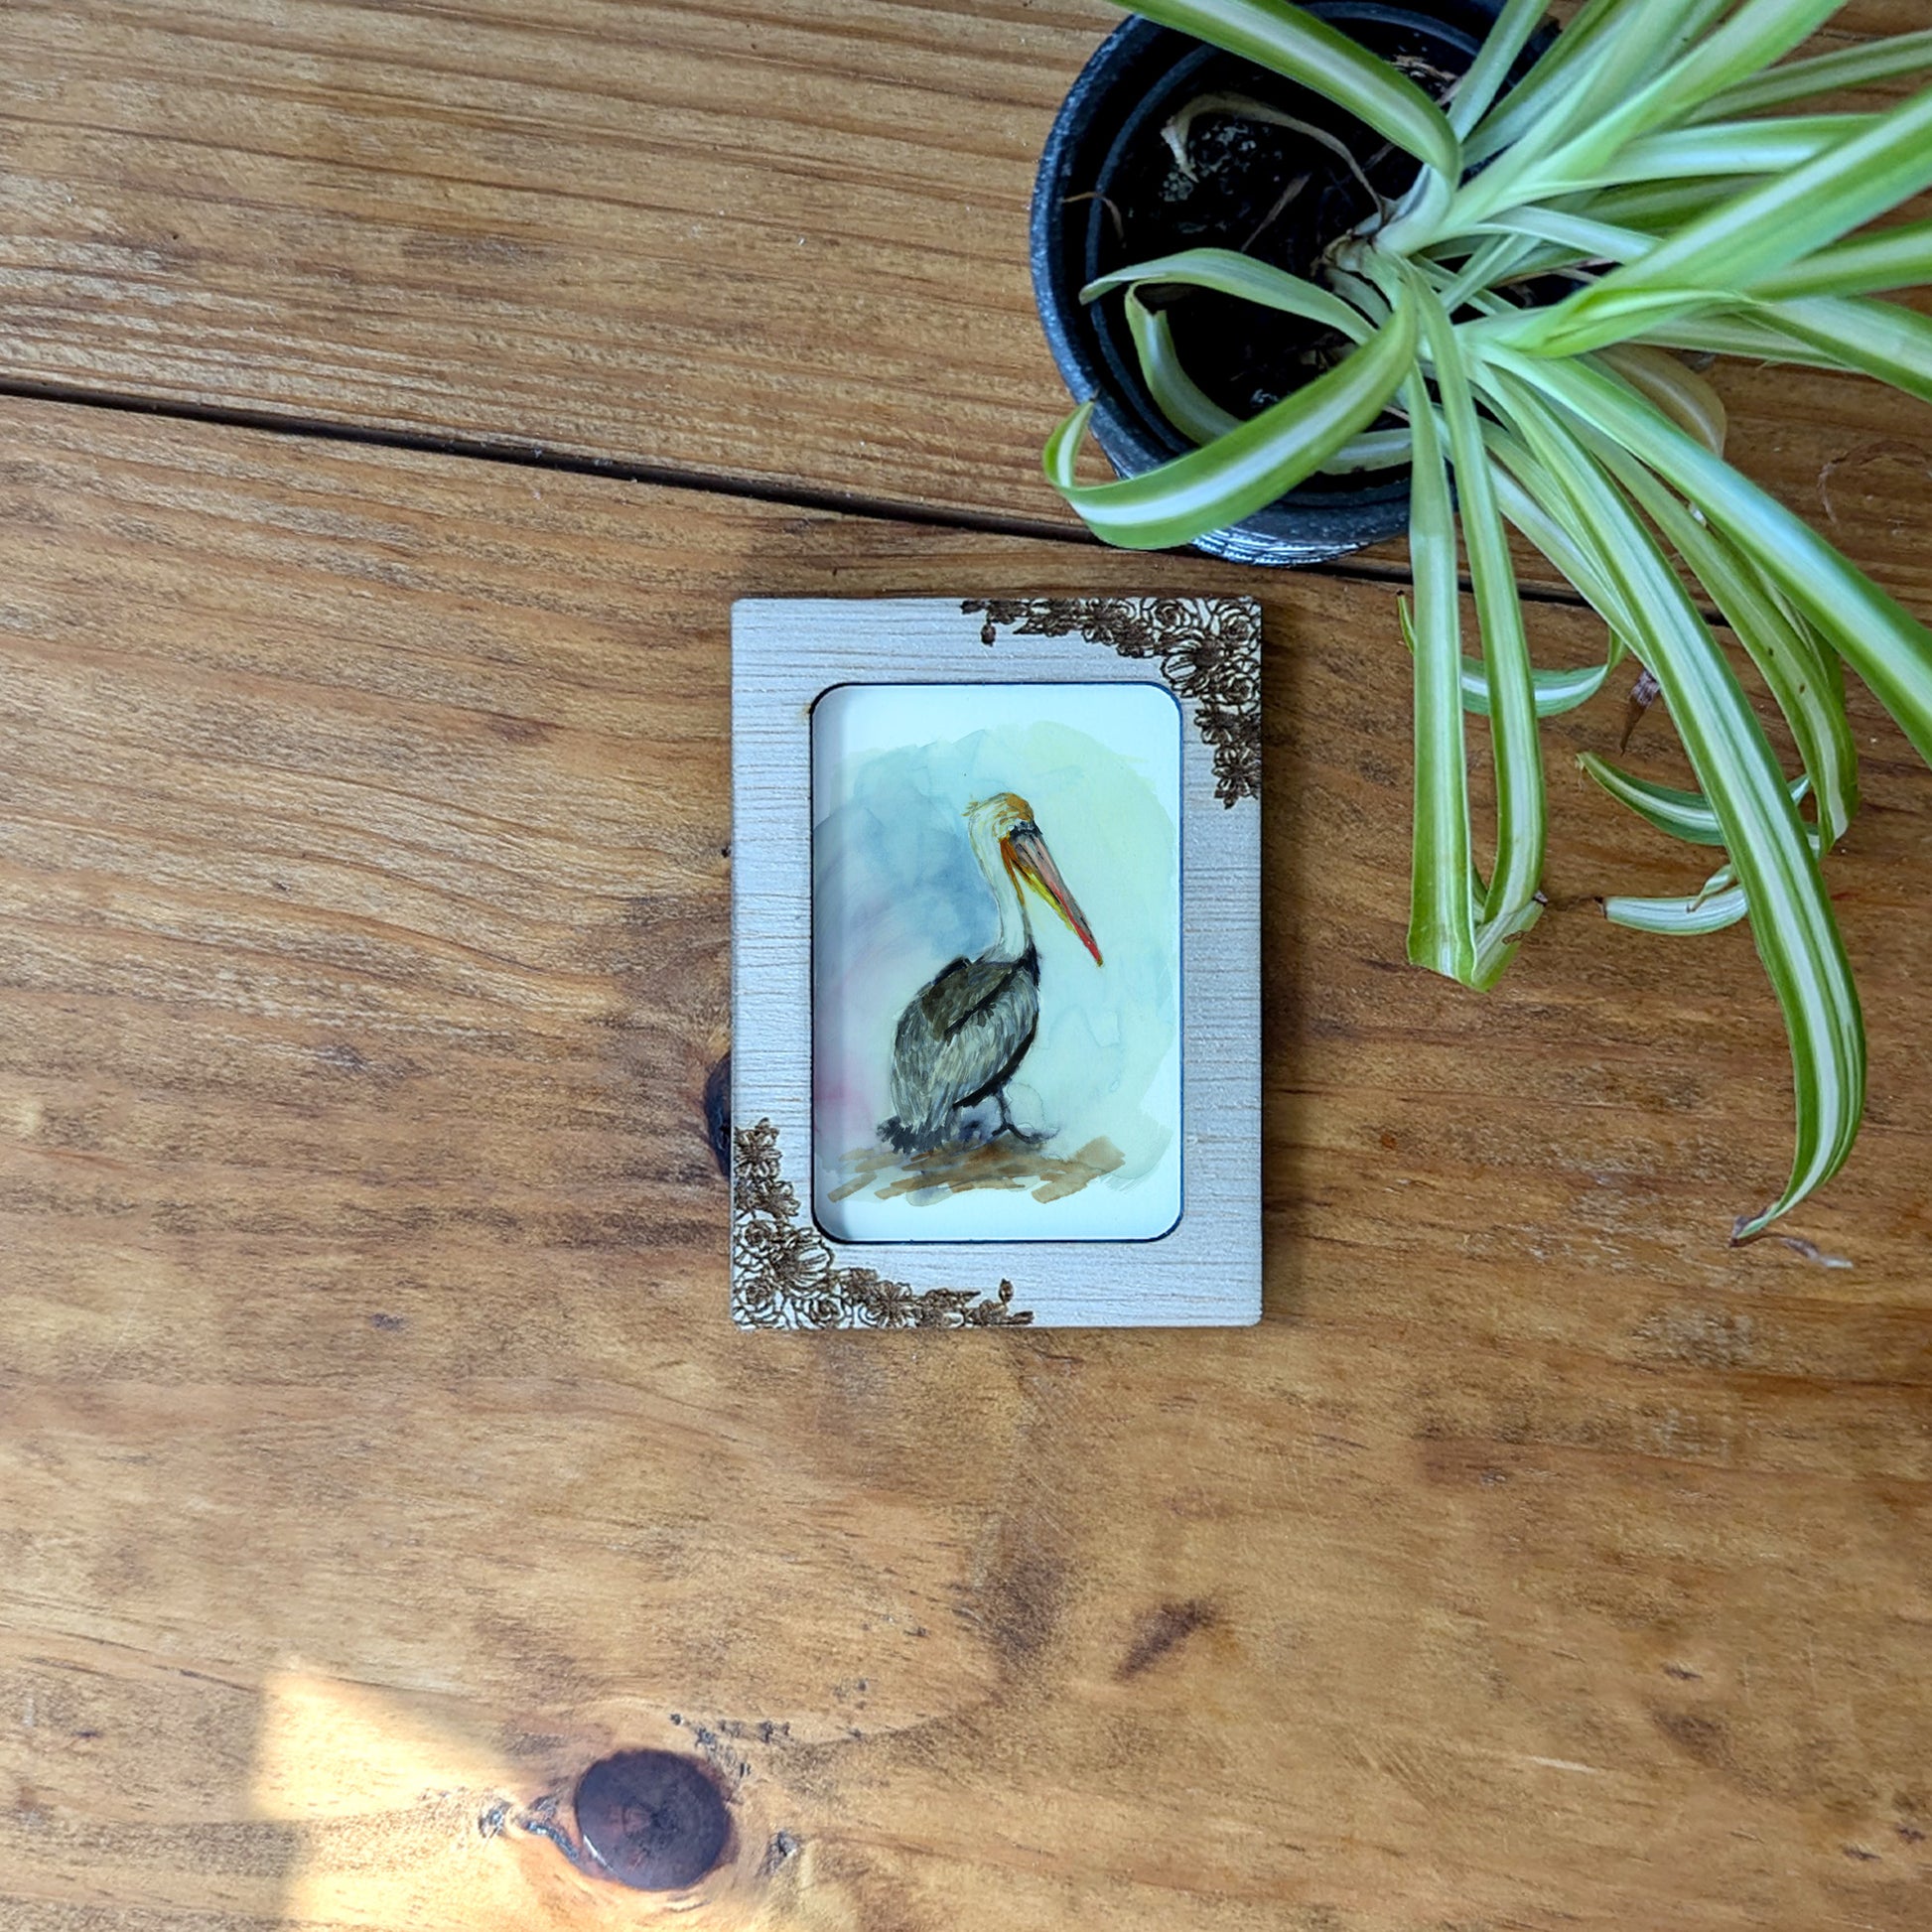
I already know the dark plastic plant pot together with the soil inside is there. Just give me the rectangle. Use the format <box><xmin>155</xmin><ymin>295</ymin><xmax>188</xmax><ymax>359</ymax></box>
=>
<box><xmin>1032</xmin><ymin>0</ymin><xmax>1550</xmax><ymax>564</ymax></box>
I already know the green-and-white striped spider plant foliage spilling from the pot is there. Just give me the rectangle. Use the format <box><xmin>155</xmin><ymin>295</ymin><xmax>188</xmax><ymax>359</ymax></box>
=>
<box><xmin>1045</xmin><ymin>0</ymin><xmax>1932</xmax><ymax>1240</ymax></box>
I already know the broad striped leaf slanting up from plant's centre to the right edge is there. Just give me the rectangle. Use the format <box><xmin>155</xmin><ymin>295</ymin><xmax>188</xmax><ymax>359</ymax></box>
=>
<box><xmin>1519</xmin><ymin>87</ymin><xmax>1932</xmax><ymax>353</ymax></box>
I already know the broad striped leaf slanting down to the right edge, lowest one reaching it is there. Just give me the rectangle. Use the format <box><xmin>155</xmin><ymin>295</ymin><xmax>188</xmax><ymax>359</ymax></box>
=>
<box><xmin>1495</xmin><ymin>349</ymin><xmax>1932</xmax><ymax>761</ymax></box>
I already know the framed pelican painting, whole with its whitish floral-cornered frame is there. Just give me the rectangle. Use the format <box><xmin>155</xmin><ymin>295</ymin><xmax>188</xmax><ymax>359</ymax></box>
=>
<box><xmin>731</xmin><ymin>597</ymin><xmax>1262</xmax><ymax>1329</ymax></box>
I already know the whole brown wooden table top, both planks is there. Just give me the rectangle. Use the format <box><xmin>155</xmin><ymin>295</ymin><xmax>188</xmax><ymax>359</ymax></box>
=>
<box><xmin>0</xmin><ymin>0</ymin><xmax>1932</xmax><ymax>1932</ymax></box>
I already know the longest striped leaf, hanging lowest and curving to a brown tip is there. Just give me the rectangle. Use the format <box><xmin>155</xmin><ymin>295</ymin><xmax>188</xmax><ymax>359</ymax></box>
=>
<box><xmin>1495</xmin><ymin>355</ymin><xmax>1864</xmax><ymax>1240</ymax></box>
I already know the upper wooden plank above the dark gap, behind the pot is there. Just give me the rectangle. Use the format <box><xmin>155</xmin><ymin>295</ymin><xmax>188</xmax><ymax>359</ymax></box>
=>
<box><xmin>0</xmin><ymin>0</ymin><xmax>1932</xmax><ymax>609</ymax></box>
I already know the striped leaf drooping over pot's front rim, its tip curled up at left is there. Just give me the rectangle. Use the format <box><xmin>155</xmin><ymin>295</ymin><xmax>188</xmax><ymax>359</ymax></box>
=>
<box><xmin>1043</xmin><ymin>305</ymin><xmax>1416</xmax><ymax>551</ymax></box>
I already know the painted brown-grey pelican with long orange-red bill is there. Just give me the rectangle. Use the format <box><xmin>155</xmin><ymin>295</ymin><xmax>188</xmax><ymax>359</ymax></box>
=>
<box><xmin>879</xmin><ymin>792</ymin><xmax>1101</xmax><ymax>1154</ymax></box>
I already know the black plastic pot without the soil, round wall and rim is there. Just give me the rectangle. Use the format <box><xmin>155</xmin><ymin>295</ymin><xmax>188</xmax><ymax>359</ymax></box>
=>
<box><xmin>1032</xmin><ymin>0</ymin><xmax>1542</xmax><ymax>564</ymax></box>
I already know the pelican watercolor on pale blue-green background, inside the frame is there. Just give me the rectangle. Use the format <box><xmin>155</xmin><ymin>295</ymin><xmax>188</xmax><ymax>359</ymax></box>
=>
<box><xmin>811</xmin><ymin>682</ymin><xmax>1182</xmax><ymax>1242</ymax></box>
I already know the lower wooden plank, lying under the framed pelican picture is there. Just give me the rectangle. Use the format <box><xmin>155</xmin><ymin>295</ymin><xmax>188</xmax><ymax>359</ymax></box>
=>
<box><xmin>0</xmin><ymin>404</ymin><xmax>1932</xmax><ymax>1932</ymax></box>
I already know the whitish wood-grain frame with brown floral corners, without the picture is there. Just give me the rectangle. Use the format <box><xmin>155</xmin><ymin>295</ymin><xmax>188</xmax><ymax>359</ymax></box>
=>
<box><xmin>733</xmin><ymin>597</ymin><xmax>1262</xmax><ymax>1327</ymax></box>
